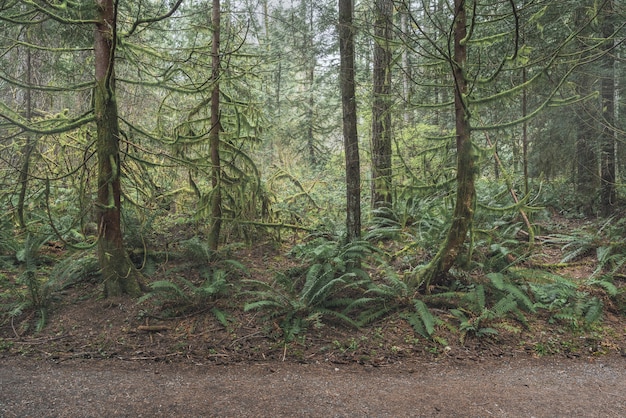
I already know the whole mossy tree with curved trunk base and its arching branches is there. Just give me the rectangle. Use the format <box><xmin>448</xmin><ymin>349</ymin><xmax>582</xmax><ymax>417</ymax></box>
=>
<box><xmin>394</xmin><ymin>0</ymin><xmax>608</xmax><ymax>290</ymax></box>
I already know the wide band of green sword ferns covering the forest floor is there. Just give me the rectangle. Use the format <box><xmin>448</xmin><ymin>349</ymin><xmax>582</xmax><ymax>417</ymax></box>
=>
<box><xmin>0</xmin><ymin>202</ymin><xmax>626</xmax><ymax>356</ymax></box>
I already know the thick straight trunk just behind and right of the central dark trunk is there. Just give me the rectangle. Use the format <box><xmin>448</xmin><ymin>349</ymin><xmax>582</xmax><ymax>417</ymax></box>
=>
<box><xmin>372</xmin><ymin>0</ymin><xmax>393</xmax><ymax>209</ymax></box>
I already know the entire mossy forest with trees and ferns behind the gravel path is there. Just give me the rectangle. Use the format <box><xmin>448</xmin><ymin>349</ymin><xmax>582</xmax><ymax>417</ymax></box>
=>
<box><xmin>0</xmin><ymin>0</ymin><xmax>626</xmax><ymax>363</ymax></box>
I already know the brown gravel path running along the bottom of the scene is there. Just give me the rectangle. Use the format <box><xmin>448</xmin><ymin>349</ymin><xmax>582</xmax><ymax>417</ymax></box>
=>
<box><xmin>0</xmin><ymin>357</ymin><xmax>626</xmax><ymax>418</ymax></box>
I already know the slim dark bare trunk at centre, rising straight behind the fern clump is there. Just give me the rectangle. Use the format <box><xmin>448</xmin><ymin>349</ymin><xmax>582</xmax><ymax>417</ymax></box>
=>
<box><xmin>339</xmin><ymin>0</ymin><xmax>361</xmax><ymax>241</ymax></box>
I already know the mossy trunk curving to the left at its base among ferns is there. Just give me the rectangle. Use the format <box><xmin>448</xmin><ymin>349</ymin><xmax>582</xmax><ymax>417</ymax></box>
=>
<box><xmin>419</xmin><ymin>0</ymin><xmax>476</xmax><ymax>291</ymax></box>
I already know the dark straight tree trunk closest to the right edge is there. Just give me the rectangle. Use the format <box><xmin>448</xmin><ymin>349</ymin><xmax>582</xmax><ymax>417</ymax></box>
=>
<box><xmin>600</xmin><ymin>0</ymin><xmax>617</xmax><ymax>216</ymax></box>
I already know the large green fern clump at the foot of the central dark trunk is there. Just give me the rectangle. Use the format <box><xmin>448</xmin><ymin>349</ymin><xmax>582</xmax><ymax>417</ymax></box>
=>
<box><xmin>244</xmin><ymin>237</ymin><xmax>373</xmax><ymax>342</ymax></box>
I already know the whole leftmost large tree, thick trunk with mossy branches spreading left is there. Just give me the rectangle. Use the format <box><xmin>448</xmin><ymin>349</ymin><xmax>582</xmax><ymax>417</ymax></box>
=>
<box><xmin>0</xmin><ymin>0</ymin><xmax>188</xmax><ymax>296</ymax></box>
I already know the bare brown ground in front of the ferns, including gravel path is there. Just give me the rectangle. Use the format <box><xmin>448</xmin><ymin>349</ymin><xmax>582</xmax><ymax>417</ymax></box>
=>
<box><xmin>0</xmin><ymin>216</ymin><xmax>626</xmax><ymax>417</ymax></box>
